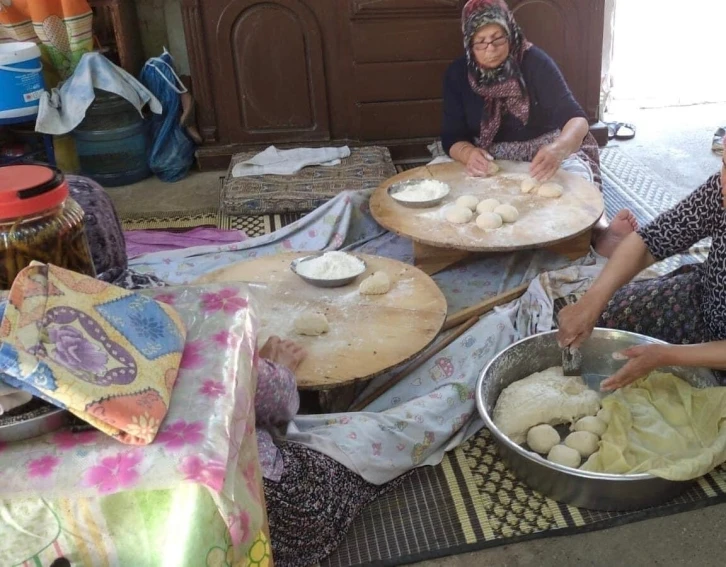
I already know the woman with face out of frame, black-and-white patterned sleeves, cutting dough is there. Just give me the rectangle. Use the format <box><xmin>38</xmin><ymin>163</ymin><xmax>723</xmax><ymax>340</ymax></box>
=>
<box><xmin>558</xmin><ymin>156</ymin><xmax>726</xmax><ymax>390</ymax></box>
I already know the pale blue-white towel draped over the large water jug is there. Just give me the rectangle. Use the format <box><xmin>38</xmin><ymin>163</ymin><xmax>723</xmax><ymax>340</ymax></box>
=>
<box><xmin>35</xmin><ymin>53</ymin><xmax>162</xmax><ymax>136</ymax></box>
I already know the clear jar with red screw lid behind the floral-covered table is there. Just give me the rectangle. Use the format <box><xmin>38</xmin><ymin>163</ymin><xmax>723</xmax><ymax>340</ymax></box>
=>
<box><xmin>0</xmin><ymin>165</ymin><xmax>96</xmax><ymax>289</ymax></box>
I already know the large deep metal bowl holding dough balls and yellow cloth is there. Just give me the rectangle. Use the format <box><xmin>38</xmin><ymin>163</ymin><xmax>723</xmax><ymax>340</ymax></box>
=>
<box><xmin>476</xmin><ymin>329</ymin><xmax>718</xmax><ymax>511</ymax></box>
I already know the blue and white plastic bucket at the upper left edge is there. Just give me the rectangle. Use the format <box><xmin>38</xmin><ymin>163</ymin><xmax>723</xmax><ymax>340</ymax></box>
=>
<box><xmin>0</xmin><ymin>41</ymin><xmax>45</xmax><ymax>120</ymax></box>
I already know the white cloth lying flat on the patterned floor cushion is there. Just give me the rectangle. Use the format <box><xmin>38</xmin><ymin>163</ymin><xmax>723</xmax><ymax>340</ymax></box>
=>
<box><xmin>232</xmin><ymin>146</ymin><xmax>350</xmax><ymax>177</ymax></box>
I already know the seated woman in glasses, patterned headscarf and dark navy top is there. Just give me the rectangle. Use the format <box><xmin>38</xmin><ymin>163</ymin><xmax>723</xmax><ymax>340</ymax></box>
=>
<box><xmin>441</xmin><ymin>0</ymin><xmax>637</xmax><ymax>256</ymax></box>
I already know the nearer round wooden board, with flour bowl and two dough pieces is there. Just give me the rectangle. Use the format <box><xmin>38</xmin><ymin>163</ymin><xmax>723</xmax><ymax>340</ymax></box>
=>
<box><xmin>197</xmin><ymin>252</ymin><xmax>447</xmax><ymax>390</ymax></box>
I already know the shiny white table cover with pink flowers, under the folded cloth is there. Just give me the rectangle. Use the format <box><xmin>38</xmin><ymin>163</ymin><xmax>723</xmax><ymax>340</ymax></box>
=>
<box><xmin>0</xmin><ymin>285</ymin><xmax>263</xmax><ymax>552</ymax></box>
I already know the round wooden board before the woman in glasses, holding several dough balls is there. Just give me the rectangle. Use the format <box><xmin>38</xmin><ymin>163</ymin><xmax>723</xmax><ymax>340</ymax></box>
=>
<box><xmin>370</xmin><ymin>161</ymin><xmax>605</xmax><ymax>252</ymax></box>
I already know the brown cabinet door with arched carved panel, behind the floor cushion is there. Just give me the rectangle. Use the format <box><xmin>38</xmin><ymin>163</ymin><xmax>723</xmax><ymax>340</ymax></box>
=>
<box><xmin>202</xmin><ymin>0</ymin><xmax>330</xmax><ymax>144</ymax></box>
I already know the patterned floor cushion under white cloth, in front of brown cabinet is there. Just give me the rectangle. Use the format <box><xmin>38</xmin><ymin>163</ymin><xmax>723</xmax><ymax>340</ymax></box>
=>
<box><xmin>221</xmin><ymin>146</ymin><xmax>396</xmax><ymax>215</ymax></box>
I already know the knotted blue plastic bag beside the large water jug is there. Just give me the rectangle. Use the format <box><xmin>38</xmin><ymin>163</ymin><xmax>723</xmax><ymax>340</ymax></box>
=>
<box><xmin>140</xmin><ymin>49</ymin><xmax>196</xmax><ymax>182</ymax></box>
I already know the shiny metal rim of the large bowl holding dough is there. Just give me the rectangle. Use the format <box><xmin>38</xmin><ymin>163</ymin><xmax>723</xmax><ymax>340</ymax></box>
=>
<box><xmin>476</xmin><ymin>329</ymin><xmax>667</xmax><ymax>482</ymax></box>
